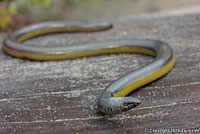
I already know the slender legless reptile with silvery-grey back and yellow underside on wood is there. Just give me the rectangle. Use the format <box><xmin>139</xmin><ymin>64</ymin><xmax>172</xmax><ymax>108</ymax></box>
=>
<box><xmin>3</xmin><ymin>21</ymin><xmax>175</xmax><ymax>114</ymax></box>
